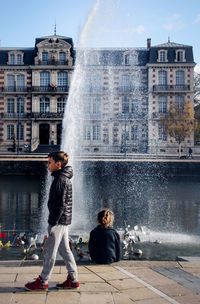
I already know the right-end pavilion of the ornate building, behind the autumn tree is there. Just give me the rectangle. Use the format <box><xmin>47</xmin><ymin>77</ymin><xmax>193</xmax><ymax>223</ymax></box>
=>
<box><xmin>147</xmin><ymin>41</ymin><xmax>195</xmax><ymax>154</ymax></box>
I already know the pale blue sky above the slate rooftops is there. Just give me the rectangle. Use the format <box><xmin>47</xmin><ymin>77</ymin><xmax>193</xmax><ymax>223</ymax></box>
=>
<box><xmin>0</xmin><ymin>0</ymin><xmax>200</xmax><ymax>64</ymax></box>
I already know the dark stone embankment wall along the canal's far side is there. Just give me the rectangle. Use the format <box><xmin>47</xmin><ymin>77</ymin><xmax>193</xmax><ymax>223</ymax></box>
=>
<box><xmin>0</xmin><ymin>160</ymin><xmax>200</xmax><ymax>177</ymax></box>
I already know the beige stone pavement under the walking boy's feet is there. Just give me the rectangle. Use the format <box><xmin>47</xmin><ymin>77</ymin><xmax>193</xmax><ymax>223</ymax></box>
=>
<box><xmin>0</xmin><ymin>261</ymin><xmax>200</xmax><ymax>304</ymax></box>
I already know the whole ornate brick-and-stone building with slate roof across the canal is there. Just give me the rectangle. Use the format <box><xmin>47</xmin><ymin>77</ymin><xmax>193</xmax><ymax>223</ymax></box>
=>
<box><xmin>0</xmin><ymin>35</ymin><xmax>194</xmax><ymax>155</ymax></box>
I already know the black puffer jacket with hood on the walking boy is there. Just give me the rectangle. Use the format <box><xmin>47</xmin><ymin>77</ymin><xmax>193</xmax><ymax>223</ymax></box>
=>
<box><xmin>48</xmin><ymin>166</ymin><xmax>73</xmax><ymax>226</ymax></box>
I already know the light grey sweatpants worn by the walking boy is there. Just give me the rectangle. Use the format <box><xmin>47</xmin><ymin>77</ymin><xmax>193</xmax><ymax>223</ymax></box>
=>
<box><xmin>41</xmin><ymin>225</ymin><xmax>77</xmax><ymax>281</ymax></box>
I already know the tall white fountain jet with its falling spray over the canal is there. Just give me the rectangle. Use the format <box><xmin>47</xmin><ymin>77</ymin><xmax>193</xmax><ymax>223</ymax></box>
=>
<box><xmin>35</xmin><ymin>0</ymin><xmax>199</xmax><ymax>258</ymax></box>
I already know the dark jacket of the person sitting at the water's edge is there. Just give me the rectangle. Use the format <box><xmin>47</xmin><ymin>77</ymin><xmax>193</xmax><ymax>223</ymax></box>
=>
<box><xmin>89</xmin><ymin>225</ymin><xmax>120</xmax><ymax>264</ymax></box>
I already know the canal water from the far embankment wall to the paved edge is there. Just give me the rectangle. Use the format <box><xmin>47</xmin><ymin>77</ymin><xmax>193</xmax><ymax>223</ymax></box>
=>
<box><xmin>0</xmin><ymin>174</ymin><xmax>200</xmax><ymax>260</ymax></box>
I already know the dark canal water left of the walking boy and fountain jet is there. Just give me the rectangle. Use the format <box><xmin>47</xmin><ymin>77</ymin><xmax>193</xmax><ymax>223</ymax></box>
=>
<box><xmin>0</xmin><ymin>176</ymin><xmax>42</xmax><ymax>232</ymax></box>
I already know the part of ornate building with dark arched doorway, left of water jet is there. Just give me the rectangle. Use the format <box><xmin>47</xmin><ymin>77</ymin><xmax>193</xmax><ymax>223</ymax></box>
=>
<box><xmin>0</xmin><ymin>35</ymin><xmax>74</xmax><ymax>152</ymax></box>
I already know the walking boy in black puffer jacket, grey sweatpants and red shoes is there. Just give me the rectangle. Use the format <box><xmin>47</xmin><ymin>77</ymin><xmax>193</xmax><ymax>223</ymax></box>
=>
<box><xmin>25</xmin><ymin>151</ymin><xmax>79</xmax><ymax>291</ymax></box>
